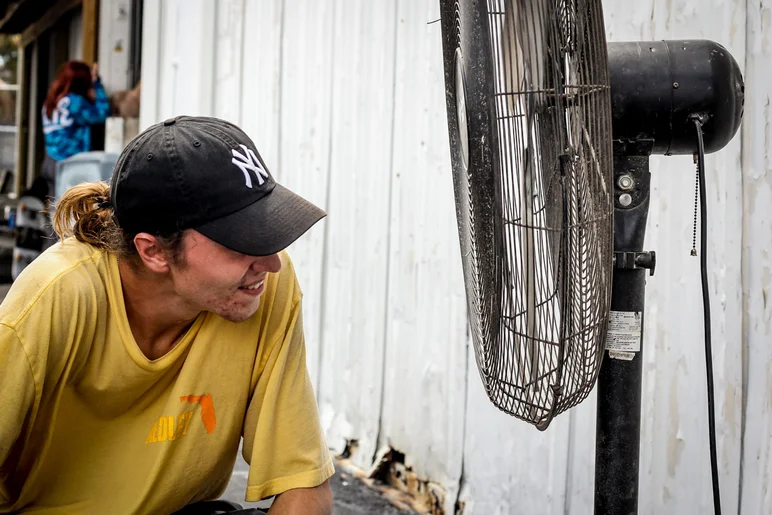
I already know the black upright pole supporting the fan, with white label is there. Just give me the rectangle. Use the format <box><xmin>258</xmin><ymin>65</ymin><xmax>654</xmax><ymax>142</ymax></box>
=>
<box><xmin>595</xmin><ymin>156</ymin><xmax>654</xmax><ymax>515</ymax></box>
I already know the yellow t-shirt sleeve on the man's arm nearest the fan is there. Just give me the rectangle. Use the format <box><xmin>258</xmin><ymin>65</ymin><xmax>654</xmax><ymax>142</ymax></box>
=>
<box><xmin>242</xmin><ymin>254</ymin><xmax>335</xmax><ymax>504</ymax></box>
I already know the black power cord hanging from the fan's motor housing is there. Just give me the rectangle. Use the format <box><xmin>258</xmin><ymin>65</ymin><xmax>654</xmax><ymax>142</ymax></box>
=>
<box><xmin>692</xmin><ymin>115</ymin><xmax>721</xmax><ymax>515</ymax></box>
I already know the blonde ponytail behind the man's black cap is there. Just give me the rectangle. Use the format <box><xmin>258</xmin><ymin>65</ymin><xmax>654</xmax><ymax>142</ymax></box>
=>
<box><xmin>53</xmin><ymin>182</ymin><xmax>124</xmax><ymax>253</ymax></box>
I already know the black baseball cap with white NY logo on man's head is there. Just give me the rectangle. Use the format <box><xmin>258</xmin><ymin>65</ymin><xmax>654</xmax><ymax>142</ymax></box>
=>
<box><xmin>110</xmin><ymin>116</ymin><xmax>326</xmax><ymax>256</ymax></box>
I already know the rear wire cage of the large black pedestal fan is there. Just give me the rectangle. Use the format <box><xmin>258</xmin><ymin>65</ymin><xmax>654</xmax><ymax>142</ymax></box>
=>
<box><xmin>462</xmin><ymin>0</ymin><xmax>613</xmax><ymax>429</ymax></box>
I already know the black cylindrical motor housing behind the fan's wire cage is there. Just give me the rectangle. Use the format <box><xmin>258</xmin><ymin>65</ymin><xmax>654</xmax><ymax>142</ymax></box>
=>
<box><xmin>608</xmin><ymin>40</ymin><xmax>745</xmax><ymax>155</ymax></box>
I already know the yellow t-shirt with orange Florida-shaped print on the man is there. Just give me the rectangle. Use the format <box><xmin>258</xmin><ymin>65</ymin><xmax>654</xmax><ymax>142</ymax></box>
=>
<box><xmin>0</xmin><ymin>239</ymin><xmax>333</xmax><ymax>514</ymax></box>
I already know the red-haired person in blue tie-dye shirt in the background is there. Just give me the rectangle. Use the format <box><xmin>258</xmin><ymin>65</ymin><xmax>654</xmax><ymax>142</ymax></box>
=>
<box><xmin>41</xmin><ymin>60</ymin><xmax>110</xmax><ymax>198</ymax></box>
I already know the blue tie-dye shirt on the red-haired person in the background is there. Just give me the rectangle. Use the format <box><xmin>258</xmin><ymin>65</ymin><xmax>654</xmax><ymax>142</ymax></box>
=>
<box><xmin>43</xmin><ymin>80</ymin><xmax>110</xmax><ymax>161</ymax></box>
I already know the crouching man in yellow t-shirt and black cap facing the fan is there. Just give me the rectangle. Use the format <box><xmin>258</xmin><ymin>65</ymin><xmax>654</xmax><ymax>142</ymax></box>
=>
<box><xmin>0</xmin><ymin>117</ymin><xmax>333</xmax><ymax>514</ymax></box>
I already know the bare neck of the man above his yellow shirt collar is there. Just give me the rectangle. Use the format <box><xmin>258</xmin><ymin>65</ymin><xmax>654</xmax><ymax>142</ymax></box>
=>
<box><xmin>118</xmin><ymin>261</ymin><xmax>198</xmax><ymax>360</ymax></box>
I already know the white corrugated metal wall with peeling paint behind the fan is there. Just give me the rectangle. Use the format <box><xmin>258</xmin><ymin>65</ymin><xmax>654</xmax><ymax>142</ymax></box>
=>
<box><xmin>141</xmin><ymin>0</ymin><xmax>772</xmax><ymax>515</ymax></box>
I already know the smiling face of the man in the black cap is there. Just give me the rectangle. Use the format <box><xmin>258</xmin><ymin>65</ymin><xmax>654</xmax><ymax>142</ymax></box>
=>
<box><xmin>171</xmin><ymin>230</ymin><xmax>281</xmax><ymax>322</ymax></box>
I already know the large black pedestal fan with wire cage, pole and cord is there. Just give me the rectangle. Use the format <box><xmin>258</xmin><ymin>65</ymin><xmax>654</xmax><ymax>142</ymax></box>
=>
<box><xmin>440</xmin><ymin>0</ymin><xmax>743</xmax><ymax>515</ymax></box>
